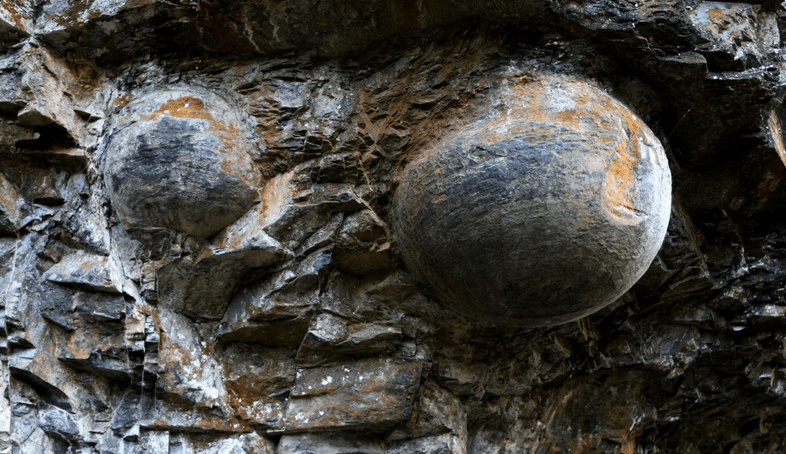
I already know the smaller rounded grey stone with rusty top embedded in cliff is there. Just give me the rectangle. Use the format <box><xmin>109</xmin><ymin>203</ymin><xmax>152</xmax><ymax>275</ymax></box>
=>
<box><xmin>102</xmin><ymin>89</ymin><xmax>260</xmax><ymax>238</ymax></box>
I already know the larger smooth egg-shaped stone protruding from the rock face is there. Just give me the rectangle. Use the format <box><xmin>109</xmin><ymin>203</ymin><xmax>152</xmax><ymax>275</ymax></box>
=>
<box><xmin>392</xmin><ymin>74</ymin><xmax>671</xmax><ymax>327</ymax></box>
